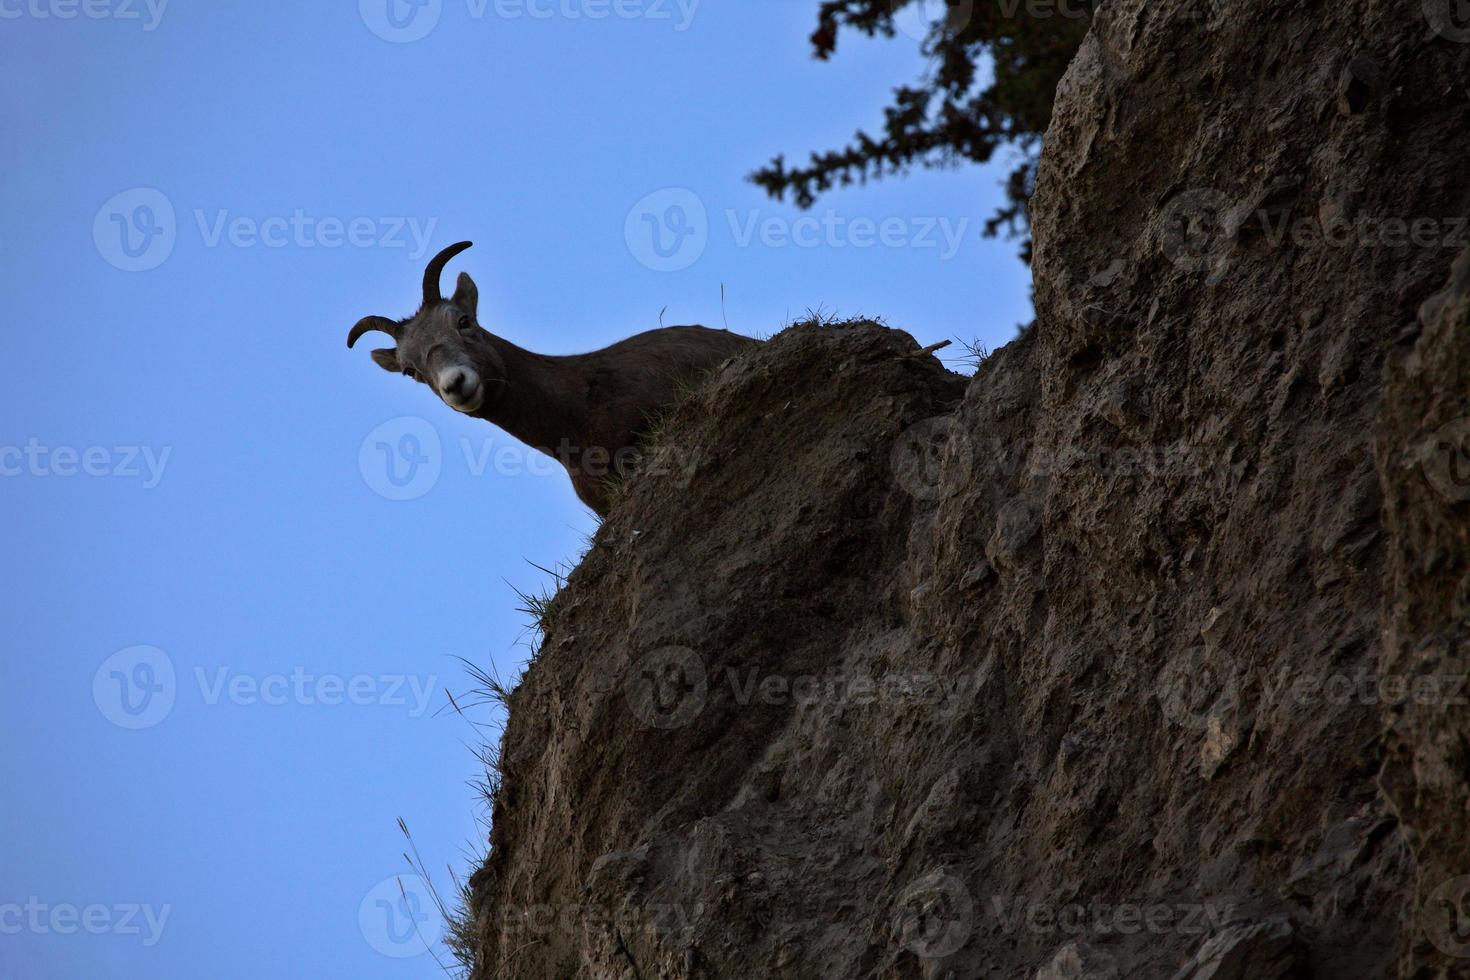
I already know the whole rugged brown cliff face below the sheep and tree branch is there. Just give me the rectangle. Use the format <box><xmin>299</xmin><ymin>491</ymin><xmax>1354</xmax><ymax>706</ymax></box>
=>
<box><xmin>470</xmin><ymin>0</ymin><xmax>1470</xmax><ymax>980</ymax></box>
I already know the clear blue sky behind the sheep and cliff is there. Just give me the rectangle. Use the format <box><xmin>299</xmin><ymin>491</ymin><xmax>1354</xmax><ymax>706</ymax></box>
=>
<box><xmin>0</xmin><ymin>0</ymin><xmax>1029</xmax><ymax>980</ymax></box>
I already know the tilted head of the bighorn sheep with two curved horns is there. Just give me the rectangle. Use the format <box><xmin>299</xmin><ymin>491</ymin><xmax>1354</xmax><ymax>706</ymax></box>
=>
<box><xmin>347</xmin><ymin>241</ymin><xmax>506</xmax><ymax>414</ymax></box>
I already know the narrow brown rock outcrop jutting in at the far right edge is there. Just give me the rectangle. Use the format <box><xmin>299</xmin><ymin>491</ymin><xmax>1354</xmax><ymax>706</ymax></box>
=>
<box><xmin>1376</xmin><ymin>250</ymin><xmax>1470</xmax><ymax>976</ymax></box>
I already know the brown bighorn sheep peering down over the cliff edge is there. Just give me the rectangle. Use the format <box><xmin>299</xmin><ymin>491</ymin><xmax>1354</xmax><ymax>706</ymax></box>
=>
<box><xmin>347</xmin><ymin>241</ymin><xmax>759</xmax><ymax>517</ymax></box>
